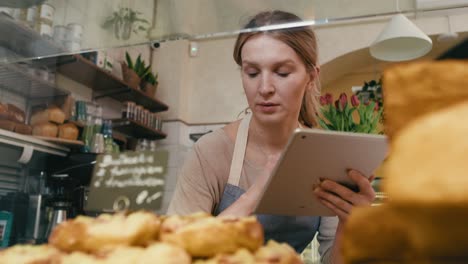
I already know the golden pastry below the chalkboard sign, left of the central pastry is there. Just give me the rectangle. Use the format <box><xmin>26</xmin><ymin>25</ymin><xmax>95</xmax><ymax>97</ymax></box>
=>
<box><xmin>49</xmin><ymin>211</ymin><xmax>160</xmax><ymax>253</ymax></box>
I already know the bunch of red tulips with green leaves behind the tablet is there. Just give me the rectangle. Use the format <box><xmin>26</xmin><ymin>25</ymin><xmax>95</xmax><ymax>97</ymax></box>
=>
<box><xmin>319</xmin><ymin>93</ymin><xmax>383</xmax><ymax>134</ymax></box>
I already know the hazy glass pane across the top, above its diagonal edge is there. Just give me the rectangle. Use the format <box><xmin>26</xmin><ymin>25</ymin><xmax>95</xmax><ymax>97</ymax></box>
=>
<box><xmin>0</xmin><ymin>0</ymin><xmax>468</xmax><ymax>63</ymax></box>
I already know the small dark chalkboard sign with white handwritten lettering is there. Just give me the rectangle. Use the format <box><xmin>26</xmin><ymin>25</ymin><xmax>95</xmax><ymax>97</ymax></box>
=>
<box><xmin>85</xmin><ymin>151</ymin><xmax>168</xmax><ymax>212</ymax></box>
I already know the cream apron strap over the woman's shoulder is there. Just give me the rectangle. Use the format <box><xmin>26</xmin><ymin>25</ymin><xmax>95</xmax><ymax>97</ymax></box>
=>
<box><xmin>228</xmin><ymin>114</ymin><xmax>252</xmax><ymax>186</ymax></box>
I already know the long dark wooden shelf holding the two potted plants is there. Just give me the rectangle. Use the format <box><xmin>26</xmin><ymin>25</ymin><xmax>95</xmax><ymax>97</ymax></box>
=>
<box><xmin>57</xmin><ymin>55</ymin><xmax>169</xmax><ymax>112</ymax></box>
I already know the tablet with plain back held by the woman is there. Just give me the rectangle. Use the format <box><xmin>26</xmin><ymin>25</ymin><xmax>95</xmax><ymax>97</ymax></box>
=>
<box><xmin>255</xmin><ymin>128</ymin><xmax>387</xmax><ymax>216</ymax></box>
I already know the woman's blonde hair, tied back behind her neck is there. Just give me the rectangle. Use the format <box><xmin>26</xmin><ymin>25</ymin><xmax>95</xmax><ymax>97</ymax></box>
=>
<box><xmin>233</xmin><ymin>10</ymin><xmax>320</xmax><ymax>127</ymax></box>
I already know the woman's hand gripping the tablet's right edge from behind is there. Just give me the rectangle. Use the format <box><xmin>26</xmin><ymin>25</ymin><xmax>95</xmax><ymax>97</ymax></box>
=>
<box><xmin>314</xmin><ymin>170</ymin><xmax>375</xmax><ymax>222</ymax></box>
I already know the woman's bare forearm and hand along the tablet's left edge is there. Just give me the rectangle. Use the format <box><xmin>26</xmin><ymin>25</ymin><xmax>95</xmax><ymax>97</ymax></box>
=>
<box><xmin>219</xmin><ymin>154</ymin><xmax>280</xmax><ymax>217</ymax></box>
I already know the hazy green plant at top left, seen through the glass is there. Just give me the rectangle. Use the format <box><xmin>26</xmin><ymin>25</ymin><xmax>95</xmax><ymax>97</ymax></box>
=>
<box><xmin>102</xmin><ymin>7</ymin><xmax>149</xmax><ymax>40</ymax></box>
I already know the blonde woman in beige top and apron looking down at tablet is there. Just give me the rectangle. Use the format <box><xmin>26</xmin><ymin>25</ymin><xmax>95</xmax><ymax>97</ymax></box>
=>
<box><xmin>168</xmin><ymin>11</ymin><xmax>374</xmax><ymax>263</ymax></box>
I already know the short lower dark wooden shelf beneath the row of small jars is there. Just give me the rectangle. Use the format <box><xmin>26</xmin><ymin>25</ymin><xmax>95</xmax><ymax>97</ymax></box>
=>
<box><xmin>112</xmin><ymin>119</ymin><xmax>167</xmax><ymax>140</ymax></box>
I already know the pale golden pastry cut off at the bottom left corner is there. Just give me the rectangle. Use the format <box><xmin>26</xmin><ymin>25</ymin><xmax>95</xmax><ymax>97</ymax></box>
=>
<box><xmin>0</xmin><ymin>245</ymin><xmax>62</xmax><ymax>264</ymax></box>
